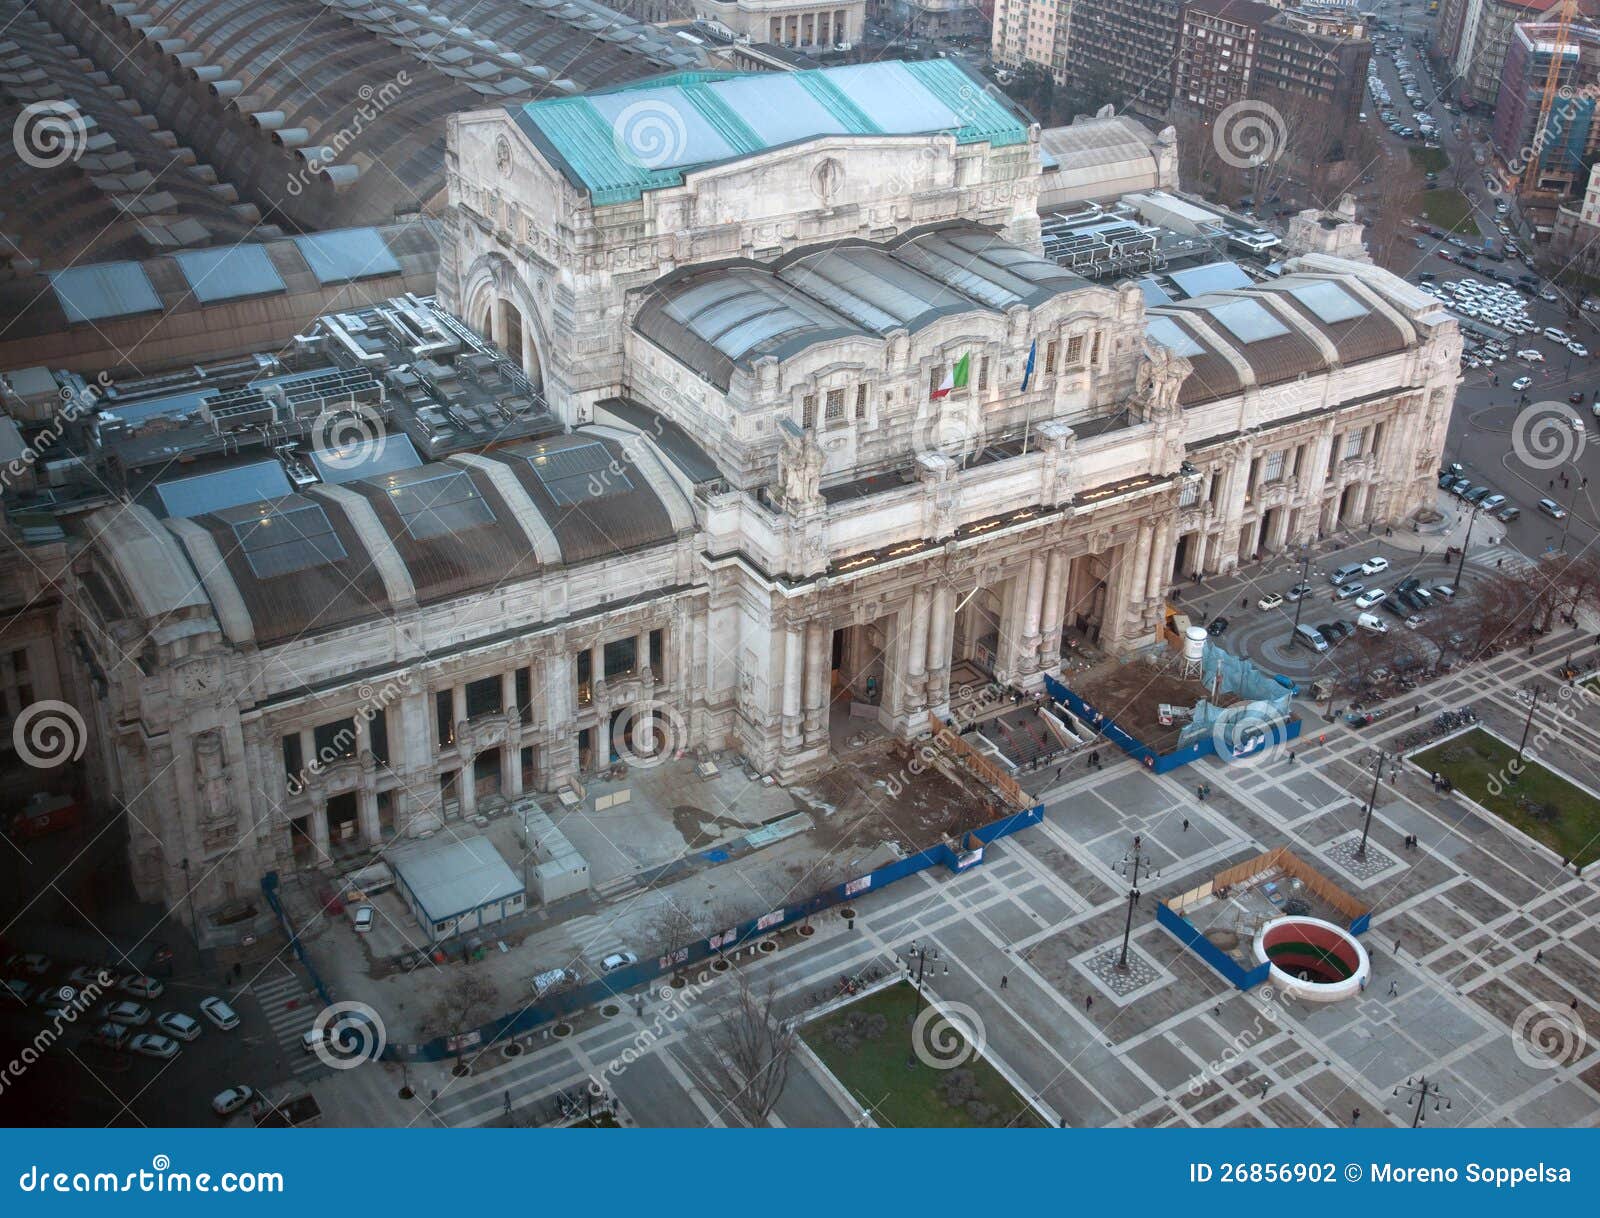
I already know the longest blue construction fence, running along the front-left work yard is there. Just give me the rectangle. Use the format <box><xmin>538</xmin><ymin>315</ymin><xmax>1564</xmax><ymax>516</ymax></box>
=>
<box><xmin>382</xmin><ymin>803</ymin><xmax>1045</xmax><ymax>1061</ymax></box>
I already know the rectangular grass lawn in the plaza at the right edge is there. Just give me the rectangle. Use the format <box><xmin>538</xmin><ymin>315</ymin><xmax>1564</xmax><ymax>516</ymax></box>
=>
<box><xmin>1411</xmin><ymin>725</ymin><xmax>1600</xmax><ymax>864</ymax></box>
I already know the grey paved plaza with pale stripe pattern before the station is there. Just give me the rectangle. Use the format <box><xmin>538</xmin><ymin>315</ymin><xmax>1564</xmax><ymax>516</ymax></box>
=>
<box><xmin>302</xmin><ymin>634</ymin><xmax>1600</xmax><ymax>1127</ymax></box>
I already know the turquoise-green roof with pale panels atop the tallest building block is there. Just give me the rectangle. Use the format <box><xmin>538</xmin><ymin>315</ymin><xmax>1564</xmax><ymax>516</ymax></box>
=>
<box><xmin>509</xmin><ymin>59</ymin><xmax>1029</xmax><ymax>205</ymax></box>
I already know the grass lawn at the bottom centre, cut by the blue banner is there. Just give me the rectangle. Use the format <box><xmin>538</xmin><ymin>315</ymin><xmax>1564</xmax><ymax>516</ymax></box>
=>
<box><xmin>800</xmin><ymin>981</ymin><xmax>1040</xmax><ymax>1128</ymax></box>
